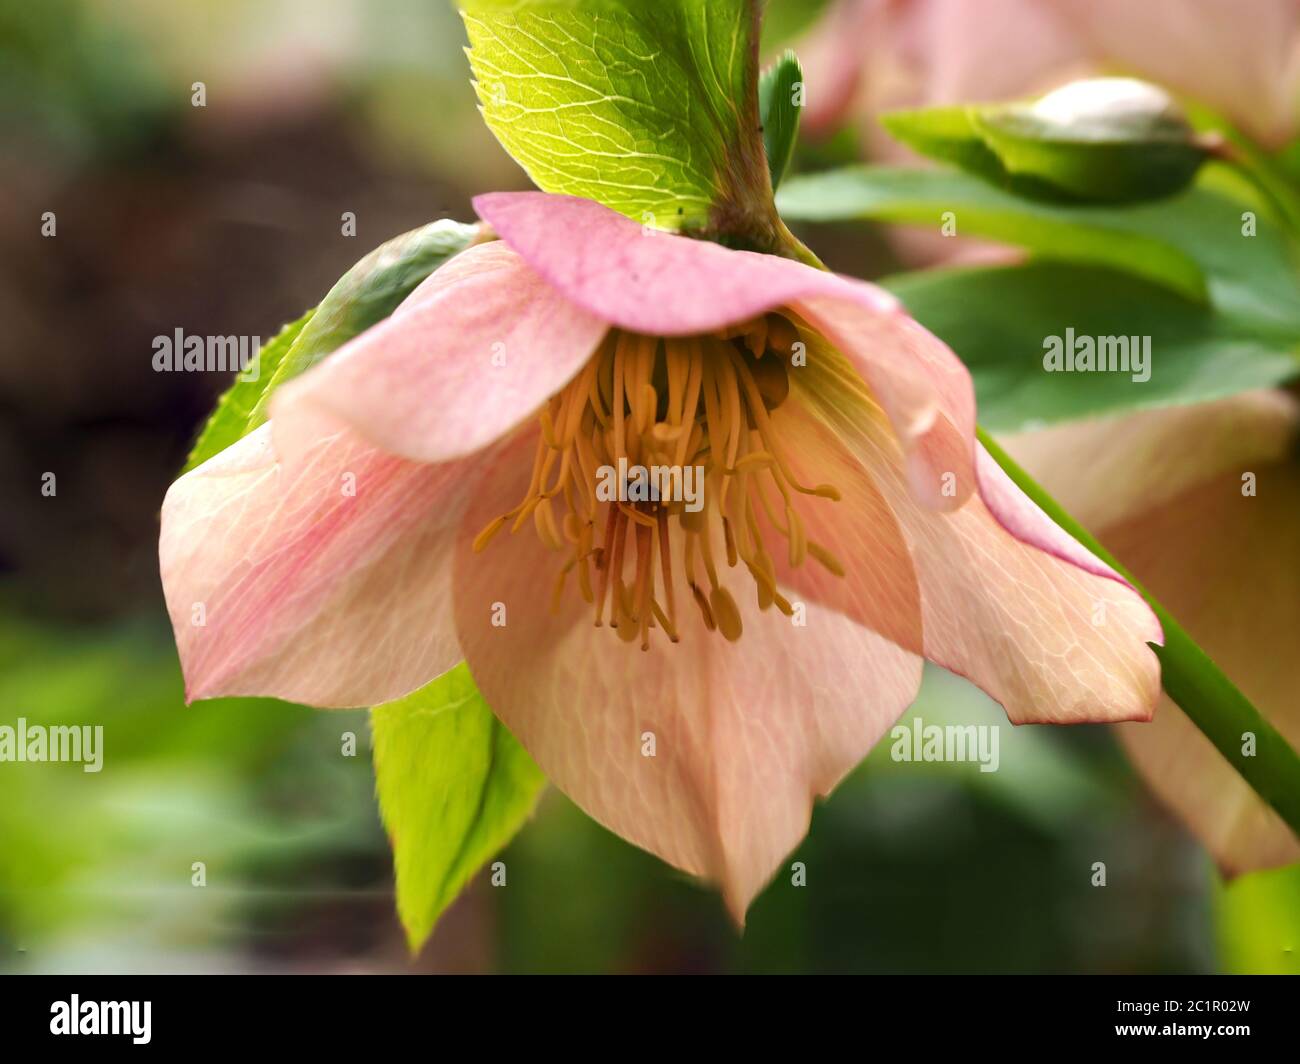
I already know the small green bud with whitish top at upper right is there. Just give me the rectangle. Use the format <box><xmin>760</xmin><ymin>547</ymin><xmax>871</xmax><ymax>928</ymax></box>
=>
<box><xmin>883</xmin><ymin>78</ymin><xmax>1210</xmax><ymax>203</ymax></box>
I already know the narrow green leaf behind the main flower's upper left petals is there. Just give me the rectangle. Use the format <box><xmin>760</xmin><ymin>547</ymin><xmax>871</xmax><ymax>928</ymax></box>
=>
<box><xmin>185</xmin><ymin>219</ymin><xmax>480</xmax><ymax>471</ymax></box>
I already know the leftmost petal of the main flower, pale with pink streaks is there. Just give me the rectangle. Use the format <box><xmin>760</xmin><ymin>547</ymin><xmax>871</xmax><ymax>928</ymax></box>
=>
<box><xmin>159</xmin><ymin>424</ymin><xmax>475</xmax><ymax>706</ymax></box>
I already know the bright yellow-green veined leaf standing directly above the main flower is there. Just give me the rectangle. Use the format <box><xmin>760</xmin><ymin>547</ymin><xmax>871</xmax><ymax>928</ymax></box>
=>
<box><xmin>462</xmin><ymin>0</ymin><xmax>779</xmax><ymax>250</ymax></box>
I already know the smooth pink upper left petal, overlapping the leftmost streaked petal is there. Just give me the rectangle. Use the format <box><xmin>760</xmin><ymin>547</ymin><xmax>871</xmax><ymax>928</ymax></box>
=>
<box><xmin>272</xmin><ymin>241</ymin><xmax>606</xmax><ymax>462</ymax></box>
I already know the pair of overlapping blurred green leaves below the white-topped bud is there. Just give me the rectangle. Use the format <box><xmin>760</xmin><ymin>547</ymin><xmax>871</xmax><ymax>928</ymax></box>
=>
<box><xmin>779</xmin><ymin>166</ymin><xmax>1300</xmax><ymax>431</ymax></box>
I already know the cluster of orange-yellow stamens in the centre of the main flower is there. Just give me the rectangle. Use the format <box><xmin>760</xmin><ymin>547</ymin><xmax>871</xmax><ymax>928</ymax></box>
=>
<box><xmin>473</xmin><ymin>313</ymin><xmax>844</xmax><ymax>650</ymax></box>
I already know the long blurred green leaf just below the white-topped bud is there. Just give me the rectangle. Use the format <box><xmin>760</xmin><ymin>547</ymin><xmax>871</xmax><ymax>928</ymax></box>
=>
<box><xmin>777</xmin><ymin>166</ymin><xmax>1300</xmax><ymax>331</ymax></box>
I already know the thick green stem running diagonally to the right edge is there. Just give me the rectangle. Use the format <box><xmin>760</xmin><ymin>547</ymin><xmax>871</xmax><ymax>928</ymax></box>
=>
<box><xmin>979</xmin><ymin>429</ymin><xmax>1300</xmax><ymax>838</ymax></box>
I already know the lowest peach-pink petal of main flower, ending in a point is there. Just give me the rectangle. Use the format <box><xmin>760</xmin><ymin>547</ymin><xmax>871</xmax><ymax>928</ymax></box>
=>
<box><xmin>455</xmin><ymin>426</ymin><xmax>920</xmax><ymax>921</ymax></box>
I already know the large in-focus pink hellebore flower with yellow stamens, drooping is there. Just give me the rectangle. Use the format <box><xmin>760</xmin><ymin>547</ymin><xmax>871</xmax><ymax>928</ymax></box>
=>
<box><xmin>160</xmin><ymin>193</ymin><xmax>1161</xmax><ymax>918</ymax></box>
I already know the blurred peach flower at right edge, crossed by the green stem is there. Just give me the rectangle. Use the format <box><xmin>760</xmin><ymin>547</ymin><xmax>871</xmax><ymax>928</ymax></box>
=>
<box><xmin>1001</xmin><ymin>392</ymin><xmax>1300</xmax><ymax>874</ymax></box>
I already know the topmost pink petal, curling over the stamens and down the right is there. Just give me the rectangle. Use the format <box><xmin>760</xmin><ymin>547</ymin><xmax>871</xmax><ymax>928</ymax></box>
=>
<box><xmin>475</xmin><ymin>193</ymin><xmax>975</xmax><ymax>507</ymax></box>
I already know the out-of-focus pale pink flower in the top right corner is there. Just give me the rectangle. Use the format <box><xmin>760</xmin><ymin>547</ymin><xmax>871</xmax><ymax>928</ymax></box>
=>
<box><xmin>800</xmin><ymin>0</ymin><xmax>1300</xmax><ymax>151</ymax></box>
